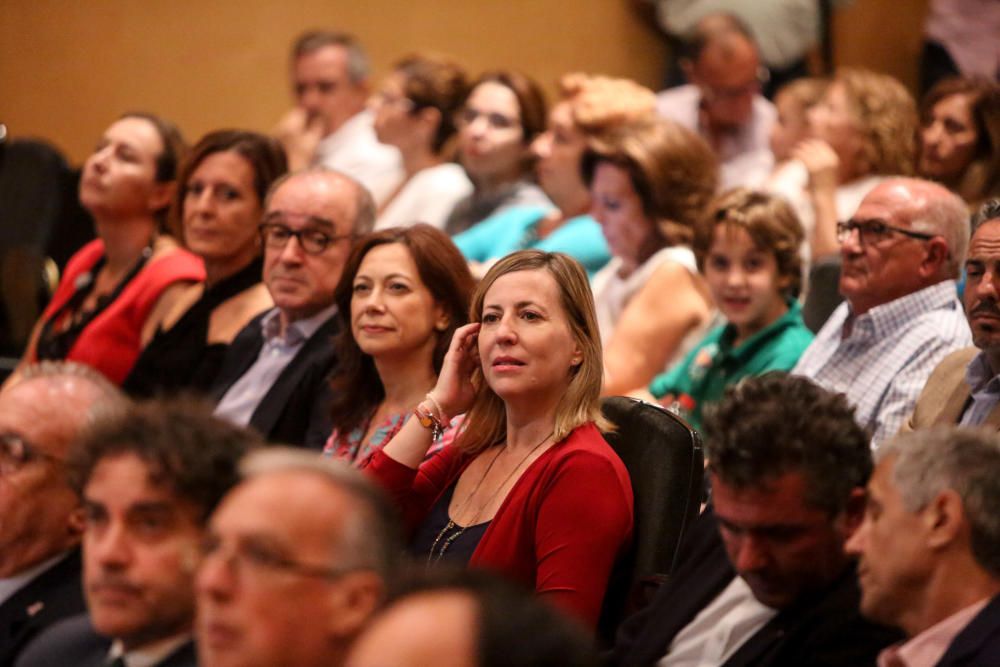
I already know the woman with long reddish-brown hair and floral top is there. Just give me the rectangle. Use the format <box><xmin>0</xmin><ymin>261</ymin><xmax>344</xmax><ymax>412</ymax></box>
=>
<box><xmin>324</xmin><ymin>224</ymin><xmax>473</xmax><ymax>463</ymax></box>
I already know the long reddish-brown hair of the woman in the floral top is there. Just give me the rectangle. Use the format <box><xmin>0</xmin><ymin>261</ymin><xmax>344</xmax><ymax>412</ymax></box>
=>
<box><xmin>330</xmin><ymin>223</ymin><xmax>475</xmax><ymax>432</ymax></box>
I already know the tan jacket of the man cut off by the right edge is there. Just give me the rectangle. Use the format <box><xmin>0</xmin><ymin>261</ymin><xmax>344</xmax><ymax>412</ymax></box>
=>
<box><xmin>901</xmin><ymin>347</ymin><xmax>1000</xmax><ymax>432</ymax></box>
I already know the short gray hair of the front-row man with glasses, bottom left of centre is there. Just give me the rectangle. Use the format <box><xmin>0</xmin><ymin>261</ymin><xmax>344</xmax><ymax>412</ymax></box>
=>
<box><xmin>240</xmin><ymin>447</ymin><xmax>402</xmax><ymax>583</ymax></box>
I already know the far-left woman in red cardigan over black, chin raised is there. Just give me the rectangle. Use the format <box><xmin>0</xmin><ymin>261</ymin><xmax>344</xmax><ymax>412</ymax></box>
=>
<box><xmin>17</xmin><ymin>113</ymin><xmax>204</xmax><ymax>384</ymax></box>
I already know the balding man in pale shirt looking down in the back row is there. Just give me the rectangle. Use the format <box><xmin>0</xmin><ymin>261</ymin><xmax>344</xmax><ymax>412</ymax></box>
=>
<box><xmin>657</xmin><ymin>14</ymin><xmax>777</xmax><ymax>189</ymax></box>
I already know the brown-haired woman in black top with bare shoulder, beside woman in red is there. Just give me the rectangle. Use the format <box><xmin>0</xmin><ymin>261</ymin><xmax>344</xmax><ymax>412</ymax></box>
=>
<box><xmin>123</xmin><ymin>130</ymin><xmax>286</xmax><ymax>396</ymax></box>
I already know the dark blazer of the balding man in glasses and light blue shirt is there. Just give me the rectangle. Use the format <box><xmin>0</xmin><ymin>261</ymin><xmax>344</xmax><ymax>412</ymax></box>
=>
<box><xmin>210</xmin><ymin>311</ymin><xmax>339</xmax><ymax>449</ymax></box>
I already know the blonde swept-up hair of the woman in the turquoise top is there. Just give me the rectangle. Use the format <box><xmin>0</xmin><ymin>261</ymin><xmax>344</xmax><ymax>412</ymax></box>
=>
<box><xmin>559</xmin><ymin>72</ymin><xmax>656</xmax><ymax>138</ymax></box>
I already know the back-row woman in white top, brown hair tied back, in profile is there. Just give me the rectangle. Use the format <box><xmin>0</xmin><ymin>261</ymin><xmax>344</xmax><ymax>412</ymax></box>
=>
<box><xmin>372</xmin><ymin>56</ymin><xmax>472</xmax><ymax>229</ymax></box>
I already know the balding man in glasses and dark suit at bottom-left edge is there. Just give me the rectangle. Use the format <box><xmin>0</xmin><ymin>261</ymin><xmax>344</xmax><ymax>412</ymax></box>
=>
<box><xmin>0</xmin><ymin>362</ymin><xmax>127</xmax><ymax>667</ymax></box>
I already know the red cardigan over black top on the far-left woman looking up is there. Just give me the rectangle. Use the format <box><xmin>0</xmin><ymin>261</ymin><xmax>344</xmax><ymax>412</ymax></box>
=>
<box><xmin>31</xmin><ymin>239</ymin><xmax>205</xmax><ymax>384</ymax></box>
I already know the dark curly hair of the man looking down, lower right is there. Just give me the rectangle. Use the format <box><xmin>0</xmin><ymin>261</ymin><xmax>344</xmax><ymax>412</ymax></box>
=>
<box><xmin>705</xmin><ymin>371</ymin><xmax>872</xmax><ymax>515</ymax></box>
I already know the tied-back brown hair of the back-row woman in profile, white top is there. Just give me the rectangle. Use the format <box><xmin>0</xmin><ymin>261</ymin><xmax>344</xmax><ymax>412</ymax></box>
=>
<box><xmin>393</xmin><ymin>55</ymin><xmax>469</xmax><ymax>154</ymax></box>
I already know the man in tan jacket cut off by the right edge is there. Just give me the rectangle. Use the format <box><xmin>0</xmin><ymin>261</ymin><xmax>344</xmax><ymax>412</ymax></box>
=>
<box><xmin>903</xmin><ymin>199</ymin><xmax>1000</xmax><ymax>431</ymax></box>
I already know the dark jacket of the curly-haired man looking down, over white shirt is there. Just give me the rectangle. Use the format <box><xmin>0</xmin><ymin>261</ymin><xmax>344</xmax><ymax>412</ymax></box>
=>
<box><xmin>609</xmin><ymin>509</ymin><xmax>901</xmax><ymax>667</ymax></box>
